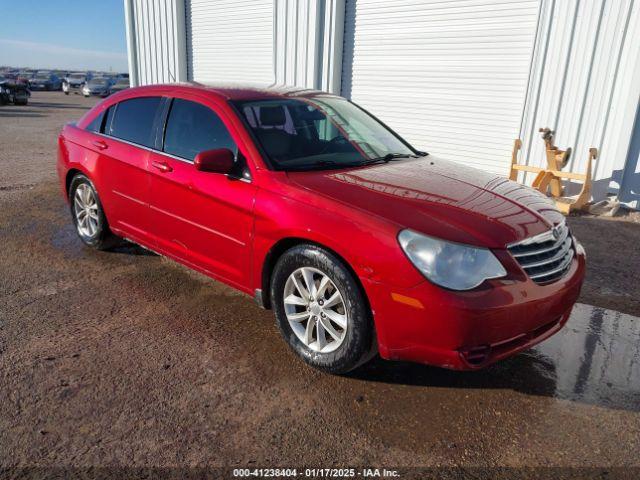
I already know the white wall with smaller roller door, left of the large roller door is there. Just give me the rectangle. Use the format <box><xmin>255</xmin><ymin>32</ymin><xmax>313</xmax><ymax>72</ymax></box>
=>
<box><xmin>125</xmin><ymin>0</ymin><xmax>345</xmax><ymax>93</ymax></box>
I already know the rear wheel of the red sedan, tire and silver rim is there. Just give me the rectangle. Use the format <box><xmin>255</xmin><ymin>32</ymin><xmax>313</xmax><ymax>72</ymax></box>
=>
<box><xmin>69</xmin><ymin>173</ymin><xmax>120</xmax><ymax>250</ymax></box>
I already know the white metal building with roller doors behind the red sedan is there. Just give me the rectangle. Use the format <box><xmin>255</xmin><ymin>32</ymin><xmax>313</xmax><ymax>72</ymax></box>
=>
<box><xmin>125</xmin><ymin>0</ymin><xmax>640</xmax><ymax>207</ymax></box>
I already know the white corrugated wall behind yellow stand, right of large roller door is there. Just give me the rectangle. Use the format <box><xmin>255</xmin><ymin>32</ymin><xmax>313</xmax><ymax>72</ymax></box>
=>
<box><xmin>521</xmin><ymin>0</ymin><xmax>640</xmax><ymax>199</ymax></box>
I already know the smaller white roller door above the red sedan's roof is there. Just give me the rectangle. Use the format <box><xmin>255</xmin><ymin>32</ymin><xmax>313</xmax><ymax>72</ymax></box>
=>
<box><xmin>185</xmin><ymin>0</ymin><xmax>274</xmax><ymax>85</ymax></box>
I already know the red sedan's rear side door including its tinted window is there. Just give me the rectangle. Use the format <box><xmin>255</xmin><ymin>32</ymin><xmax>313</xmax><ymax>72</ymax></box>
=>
<box><xmin>93</xmin><ymin>97</ymin><xmax>164</xmax><ymax>243</ymax></box>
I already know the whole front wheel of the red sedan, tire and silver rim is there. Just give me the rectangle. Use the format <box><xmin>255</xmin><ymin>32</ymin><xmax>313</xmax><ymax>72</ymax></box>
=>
<box><xmin>270</xmin><ymin>244</ymin><xmax>375</xmax><ymax>374</ymax></box>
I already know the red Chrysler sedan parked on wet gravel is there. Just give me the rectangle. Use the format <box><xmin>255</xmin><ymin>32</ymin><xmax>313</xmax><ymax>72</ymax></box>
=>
<box><xmin>58</xmin><ymin>84</ymin><xmax>585</xmax><ymax>373</ymax></box>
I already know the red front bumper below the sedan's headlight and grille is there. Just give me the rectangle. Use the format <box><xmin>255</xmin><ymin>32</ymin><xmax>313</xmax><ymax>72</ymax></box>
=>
<box><xmin>363</xmin><ymin>252</ymin><xmax>585</xmax><ymax>370</ymax></box>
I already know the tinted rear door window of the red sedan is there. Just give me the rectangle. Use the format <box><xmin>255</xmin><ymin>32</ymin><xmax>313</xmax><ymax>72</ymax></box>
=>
<box><xmin>109</xmin><ymin>97</ymin><xmax>161</xmax><ymax>147</ymax></box>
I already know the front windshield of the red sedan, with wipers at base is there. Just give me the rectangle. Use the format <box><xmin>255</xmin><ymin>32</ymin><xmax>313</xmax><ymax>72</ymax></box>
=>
<box><xmin>235</xmin><ymin>96</ymin><xmax>416</xmax><ymax>170</ymax></box>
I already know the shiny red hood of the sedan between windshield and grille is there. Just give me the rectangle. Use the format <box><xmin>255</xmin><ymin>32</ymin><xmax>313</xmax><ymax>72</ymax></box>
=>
<box><xmin>288</xmin><ymin>155</ymin><xmax>564</xmax><ymax>248</ymax></box>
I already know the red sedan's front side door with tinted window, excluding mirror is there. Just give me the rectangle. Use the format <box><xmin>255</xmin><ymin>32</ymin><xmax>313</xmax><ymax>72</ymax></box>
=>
<box><xmin>149</xmin><ymin>96</ymin><xmax>256</xmax><ymax>288</ymax></box>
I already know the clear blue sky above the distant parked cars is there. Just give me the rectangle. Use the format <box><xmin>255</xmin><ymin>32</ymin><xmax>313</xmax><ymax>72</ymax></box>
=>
<box><xmin>0</xmin><ymin>0</ymin><xmax>127</xmax><ymax>72</ymax></box>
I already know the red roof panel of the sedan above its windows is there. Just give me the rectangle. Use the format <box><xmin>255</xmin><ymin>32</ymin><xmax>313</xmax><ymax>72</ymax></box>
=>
<box><xmin>122</xmin><ymin>82</ymin><xmax>335</xmax><ymax>100</ymax></box>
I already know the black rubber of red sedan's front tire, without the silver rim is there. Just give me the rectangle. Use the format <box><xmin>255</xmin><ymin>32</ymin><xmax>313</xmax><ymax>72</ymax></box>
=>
<box><xmin>270</xmin><ymin>244</ymin><xmax>373</xmax><ymax>374</ymax></box>
